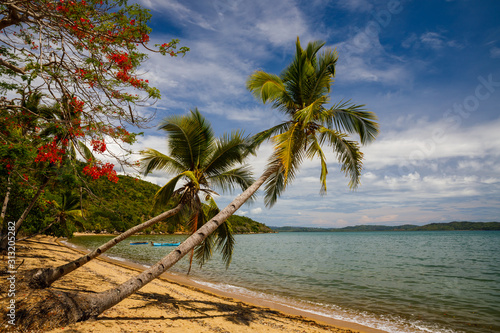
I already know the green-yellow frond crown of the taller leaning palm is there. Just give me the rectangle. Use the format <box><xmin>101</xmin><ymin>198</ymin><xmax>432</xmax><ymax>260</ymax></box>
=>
<box><xmin>247</xmin><ymin>38</ymin><xmax>378</xmax><ymax>206</ymax></box>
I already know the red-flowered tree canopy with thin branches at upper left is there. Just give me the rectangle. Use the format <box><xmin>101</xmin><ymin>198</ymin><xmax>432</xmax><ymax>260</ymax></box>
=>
<box><xmin>0</xmin><ymin>0</ymin><xmax>188</xmax><ymax>192</ymax></box>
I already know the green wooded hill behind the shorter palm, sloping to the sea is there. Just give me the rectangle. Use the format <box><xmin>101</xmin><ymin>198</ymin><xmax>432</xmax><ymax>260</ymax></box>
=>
<box><xmin>78</xmin><ymin>176</ymin><xmax>274</xmax><ymax>233</ymax></box>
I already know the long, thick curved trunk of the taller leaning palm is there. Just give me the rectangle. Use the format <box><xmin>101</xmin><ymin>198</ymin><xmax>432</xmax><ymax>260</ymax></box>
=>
<box><xmin>44</xmin><ymin>167</ymin><xmax>278</xmax><ymax>324</ymax></box>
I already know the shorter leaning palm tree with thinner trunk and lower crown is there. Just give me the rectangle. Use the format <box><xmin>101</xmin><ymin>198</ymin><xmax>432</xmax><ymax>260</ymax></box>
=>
<box><xmin>28</xmin><ymin>110</ymin><xmax>253</xmax><ymax>288</ymax></box>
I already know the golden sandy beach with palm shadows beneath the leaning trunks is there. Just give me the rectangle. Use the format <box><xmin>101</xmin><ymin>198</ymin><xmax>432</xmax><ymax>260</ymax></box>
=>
<box><xmin>0</xmin><ymin>236</ymin><xmax>382</xmax><ymax>333</ymax></box>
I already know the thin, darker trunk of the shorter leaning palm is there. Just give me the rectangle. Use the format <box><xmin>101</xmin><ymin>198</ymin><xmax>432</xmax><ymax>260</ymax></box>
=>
<box><xmin>28</xmin><ymin>203</ymin><xmax>184</xmax><ymax>289</ymax></box>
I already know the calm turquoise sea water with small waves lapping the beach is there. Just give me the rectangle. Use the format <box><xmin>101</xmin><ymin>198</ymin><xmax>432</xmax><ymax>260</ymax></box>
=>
<box><xmin>71</xmin><ymin>231</ymin><xmax>500</xmax><ymax>333</ymax></box>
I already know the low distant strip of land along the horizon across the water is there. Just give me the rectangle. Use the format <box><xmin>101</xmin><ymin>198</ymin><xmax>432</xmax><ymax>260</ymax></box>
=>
<box><xmin>270</xmin><ymin>221</ymin><xmax>500</xmax><ymax>232</ymax></box>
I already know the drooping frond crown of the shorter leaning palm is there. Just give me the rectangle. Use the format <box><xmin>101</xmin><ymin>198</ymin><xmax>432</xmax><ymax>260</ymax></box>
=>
<box><xmin>142</xmin><ymin>109</ymin><xmax>254</xmax><ymax>265</ymax></box>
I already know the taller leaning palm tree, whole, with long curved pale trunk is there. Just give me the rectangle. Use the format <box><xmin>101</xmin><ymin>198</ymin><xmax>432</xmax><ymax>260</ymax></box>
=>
<box><xmin>20</xmin><ymin>39</ymin><xmax>378</xmax><ymax>328</ymax></box>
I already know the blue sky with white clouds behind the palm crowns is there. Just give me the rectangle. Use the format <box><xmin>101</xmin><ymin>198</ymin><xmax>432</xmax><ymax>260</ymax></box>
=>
<box><xmin>122</xmin><ymin>0</ymin><xmax>500</xmax><ymax>227</ymax></box>
